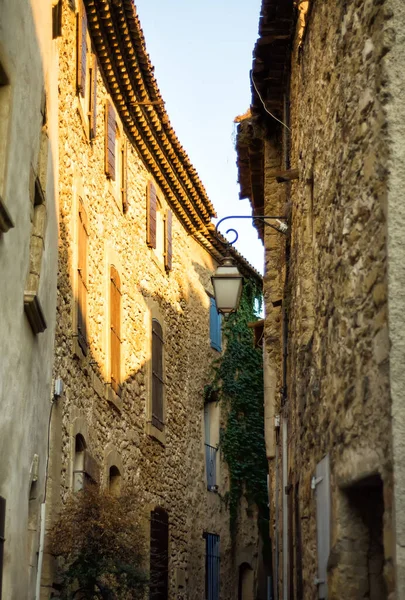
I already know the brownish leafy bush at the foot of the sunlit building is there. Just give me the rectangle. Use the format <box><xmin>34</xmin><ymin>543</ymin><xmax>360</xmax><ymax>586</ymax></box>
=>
<box><xmin>50</xmin><ymin>486</ymin><xmax>147</xmax><ymax>600</ymax></box>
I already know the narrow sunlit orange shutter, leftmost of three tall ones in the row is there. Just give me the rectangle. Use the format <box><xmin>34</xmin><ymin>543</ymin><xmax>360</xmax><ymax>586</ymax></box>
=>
<box><xmin>77</xmin><ymin>200</ymin><xmax>88</xmax><ymax>355</ymax></box>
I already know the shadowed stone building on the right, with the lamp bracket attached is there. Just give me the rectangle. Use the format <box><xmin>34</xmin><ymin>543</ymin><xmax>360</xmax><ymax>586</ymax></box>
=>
<box><xmin>237</xmin><ymin>0</ymin><xmax>405</xmax><ymax>600</ymax></box>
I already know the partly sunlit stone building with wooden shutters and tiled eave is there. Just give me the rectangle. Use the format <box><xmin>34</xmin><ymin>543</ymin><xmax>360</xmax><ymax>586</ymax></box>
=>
<box><xmin>41</xmin><ymin>0</ymin><xmax>261</xmax><ymax>600</ymax></box>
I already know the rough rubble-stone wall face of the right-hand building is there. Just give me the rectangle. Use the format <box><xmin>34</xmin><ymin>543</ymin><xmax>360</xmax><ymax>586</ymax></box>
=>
<box><xmin>260</xmin><ymin>0</ymin><xmax>399</xmax><ymax>599</ymax></box>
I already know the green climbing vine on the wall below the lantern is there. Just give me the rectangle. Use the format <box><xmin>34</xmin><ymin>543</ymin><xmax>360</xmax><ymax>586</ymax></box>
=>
<box><xmin>206</xmin><ymin>280</ymin><xmax>270</xmax><ymax>552</ymax></box>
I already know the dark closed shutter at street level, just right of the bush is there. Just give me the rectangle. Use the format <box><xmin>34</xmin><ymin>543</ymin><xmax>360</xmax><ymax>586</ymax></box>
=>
<box><xmin>150</xmin><ymin>508</ymin><xmax>169</xmax><ymax>600</ymax></box>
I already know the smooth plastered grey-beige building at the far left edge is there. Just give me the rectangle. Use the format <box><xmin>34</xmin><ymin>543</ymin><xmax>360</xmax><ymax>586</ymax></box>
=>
<box><xmin>0</xmin><ymin>0</ymin><xmax>59</xmax><ymax>600</ymax></box>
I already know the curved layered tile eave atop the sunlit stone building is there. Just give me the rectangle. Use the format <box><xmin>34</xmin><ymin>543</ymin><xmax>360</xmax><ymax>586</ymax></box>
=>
<box><xmin>84</xmin><ymin>0</ymin><xmax>215</xmax><ymax>234</ymax></box>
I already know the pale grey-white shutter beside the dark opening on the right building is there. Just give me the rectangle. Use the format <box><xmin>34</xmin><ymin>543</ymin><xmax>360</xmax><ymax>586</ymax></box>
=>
<box><xmin>312</xmin><ymin>454</ymin><xmax>331</xmax><ymax>600</ymax></box>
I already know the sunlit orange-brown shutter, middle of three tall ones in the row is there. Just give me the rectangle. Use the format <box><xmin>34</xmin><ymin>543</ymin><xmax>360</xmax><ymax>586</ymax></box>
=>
<box><xmin>110</xmin><ymin>266</ymin><xmax>121</xmax><ymax>396</ymax></box>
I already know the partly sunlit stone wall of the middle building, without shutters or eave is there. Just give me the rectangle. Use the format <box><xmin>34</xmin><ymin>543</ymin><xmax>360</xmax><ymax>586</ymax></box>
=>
<box><xmin>42</xmin><ymin>3</ymin><xmax>258</xmax><ymax>599</ymax></box>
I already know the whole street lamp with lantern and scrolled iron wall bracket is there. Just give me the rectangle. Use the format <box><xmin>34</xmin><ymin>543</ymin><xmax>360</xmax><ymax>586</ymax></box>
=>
<box><xmin>211</xmin><ymin>215</ymin><xmax>287</xmax><ymax>315</ymax></box>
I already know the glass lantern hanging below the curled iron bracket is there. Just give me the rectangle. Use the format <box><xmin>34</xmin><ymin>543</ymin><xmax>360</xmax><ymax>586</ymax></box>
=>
<box><xmin>211</xmin><ymin>257</ymin><xmax>243</xmax><ymax>315</ymax></box>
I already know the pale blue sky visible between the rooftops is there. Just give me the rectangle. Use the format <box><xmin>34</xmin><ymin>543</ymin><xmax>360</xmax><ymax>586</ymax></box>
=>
<box><xmin>135</xmin><ymin>0</ymin><xmax>263</xmax><ymax>271</ymax></box>
